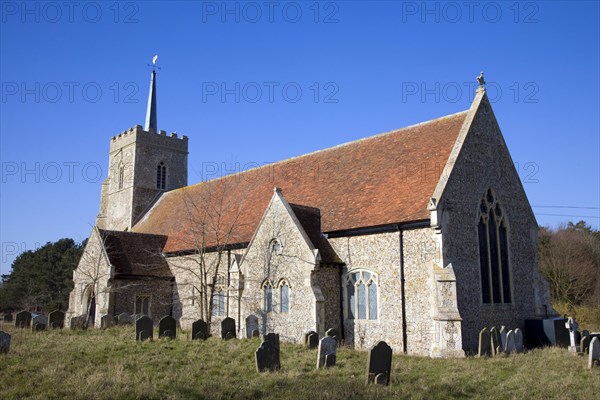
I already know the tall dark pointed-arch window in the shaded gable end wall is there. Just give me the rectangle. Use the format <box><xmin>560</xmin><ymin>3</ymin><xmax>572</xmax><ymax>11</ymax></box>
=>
<box><xmin>477</xmin><ymin>189</ymin><xmax>512</xmax><ymax>304</ymax></box>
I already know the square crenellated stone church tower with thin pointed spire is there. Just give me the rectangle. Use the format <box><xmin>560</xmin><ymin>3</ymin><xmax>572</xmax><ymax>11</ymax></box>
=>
<box><xmin>96</xmin><ymin>61</ymin><xmax>188</xmax><ymax>231</ymax></box>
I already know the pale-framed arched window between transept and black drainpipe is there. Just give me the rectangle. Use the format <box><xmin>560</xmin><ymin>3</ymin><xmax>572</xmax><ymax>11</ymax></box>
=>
<box><xmin>344</xmin><ymin>270</ymin><xmax>378</xmax><ymax>320</ymax></box>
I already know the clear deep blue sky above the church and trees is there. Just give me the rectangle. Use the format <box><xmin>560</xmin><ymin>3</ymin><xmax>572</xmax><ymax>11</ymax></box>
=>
<box><xmin>0</xmin><ymin>1</ymin><xmax>600</xmax><ymax>273</ymax></box>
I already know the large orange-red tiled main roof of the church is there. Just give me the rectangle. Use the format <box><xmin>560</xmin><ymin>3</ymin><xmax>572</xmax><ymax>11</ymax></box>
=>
<box><xmin>133</xmin><ymin>111</ymin><xmax>467</xmax><ymax>252</ymax></box>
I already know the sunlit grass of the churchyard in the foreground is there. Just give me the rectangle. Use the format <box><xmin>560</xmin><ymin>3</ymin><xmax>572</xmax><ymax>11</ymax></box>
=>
<box><xmin>0</xmin><ymin>324</ymin><xmax>600</xmax><ymax>400</ymax></box>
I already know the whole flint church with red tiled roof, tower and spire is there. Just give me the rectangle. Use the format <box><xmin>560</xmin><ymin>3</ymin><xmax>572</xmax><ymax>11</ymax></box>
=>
<box><xmin>67</xmin><ymin>71</ymin><xmax>550</xmax><ymax>357</ymax></box>
